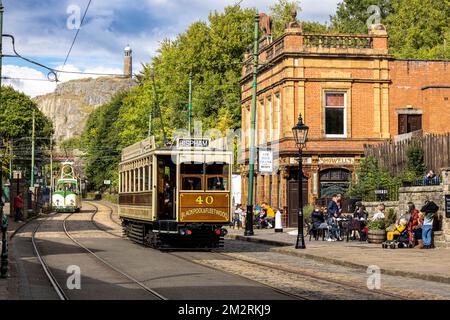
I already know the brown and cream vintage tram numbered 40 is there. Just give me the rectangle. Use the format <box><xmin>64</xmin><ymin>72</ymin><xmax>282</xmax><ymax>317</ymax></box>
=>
<box><xmin>119</xmin><ymin>137</ymin><xmax>233</xmax><ymax>248</ymax></box>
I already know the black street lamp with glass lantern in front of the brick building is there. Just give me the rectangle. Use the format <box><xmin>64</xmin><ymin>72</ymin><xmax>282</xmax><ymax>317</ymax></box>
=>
<box><xmin>292</xmin><ymin>114</ymin><xmax>309</xmax><ymax>249</ymax></box>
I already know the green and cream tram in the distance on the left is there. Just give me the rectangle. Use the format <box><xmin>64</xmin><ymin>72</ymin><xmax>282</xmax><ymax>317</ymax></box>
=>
<box><xmin>52</xmin><ymin>162</ymin><xmax>81</xmax><ymax>212</ymax></box>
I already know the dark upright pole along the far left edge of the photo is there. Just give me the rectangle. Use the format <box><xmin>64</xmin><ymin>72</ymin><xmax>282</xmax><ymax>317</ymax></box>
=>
<box><xmin>0</xmin><ymin>0</ymin><xmax>8</xmax><ymax>278</ymax></box>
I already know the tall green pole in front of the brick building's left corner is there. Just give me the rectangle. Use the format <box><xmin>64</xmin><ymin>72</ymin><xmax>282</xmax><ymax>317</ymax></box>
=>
<box><xmin>244</xmin><ymin>11</ymin><xmax>259</xmax><ymax>236</ymax></box>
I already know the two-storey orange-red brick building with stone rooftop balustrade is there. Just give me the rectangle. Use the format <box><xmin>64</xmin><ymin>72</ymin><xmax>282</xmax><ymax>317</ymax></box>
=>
<box><xmin>241</xmin><ymin>24</ymin><xmax>450</xmax><ymax>225</ymax></box>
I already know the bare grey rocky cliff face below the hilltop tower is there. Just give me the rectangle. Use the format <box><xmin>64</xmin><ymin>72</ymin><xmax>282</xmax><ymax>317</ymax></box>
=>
<box><xmin>33</xmin><ymin>77</ymin><xmax>136</xmax><ymax>141</ymax></box>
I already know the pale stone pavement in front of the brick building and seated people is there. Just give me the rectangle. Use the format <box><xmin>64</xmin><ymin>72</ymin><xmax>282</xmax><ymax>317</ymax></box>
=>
<box><xmin>226</xmin><ymin>228</ymin><xmax>450</xmax><ymax>283</ymax></box>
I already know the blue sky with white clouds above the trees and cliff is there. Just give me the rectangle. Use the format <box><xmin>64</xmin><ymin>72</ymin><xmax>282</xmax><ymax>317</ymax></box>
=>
<box><xmin>2</xmin><ymin>0</ymin><xmax>339</xmax><ymax>97</ymax></box>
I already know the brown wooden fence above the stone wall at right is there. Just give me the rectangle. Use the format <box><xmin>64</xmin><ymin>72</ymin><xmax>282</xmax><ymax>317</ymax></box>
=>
<box><xmin>364</xmin><ymin>133</ymin><xmax>450</xmax><ymax>175</ymax></box>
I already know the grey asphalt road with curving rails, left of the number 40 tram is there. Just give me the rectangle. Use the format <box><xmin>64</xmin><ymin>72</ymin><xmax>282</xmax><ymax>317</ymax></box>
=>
<box><xmin>13</xmin><ymin>205</ymin><xmax>292</xmax><ymax>300</ymax></box>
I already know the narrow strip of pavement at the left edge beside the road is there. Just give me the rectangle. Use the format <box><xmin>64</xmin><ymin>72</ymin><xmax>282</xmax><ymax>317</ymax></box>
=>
<box><xmin>0</xmin><ymin>203</ymin><xmax>24</xmax><ymax>300</ymax></box>
